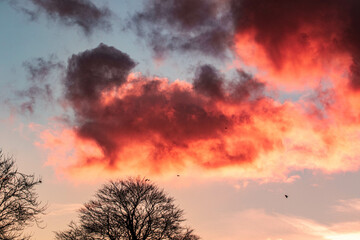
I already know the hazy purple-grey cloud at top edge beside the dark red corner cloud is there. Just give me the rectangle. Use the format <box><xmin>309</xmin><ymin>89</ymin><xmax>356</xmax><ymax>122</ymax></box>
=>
<box><xmin>130</xmin><ymin>0</ymin><xmax>233</xmax><ymax>57</ymax></box>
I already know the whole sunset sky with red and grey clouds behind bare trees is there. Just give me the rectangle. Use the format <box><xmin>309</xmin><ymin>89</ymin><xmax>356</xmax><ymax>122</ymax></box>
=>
<box><xmin>0</xmin><ymin>0</ymin><xmax>360</xmax><ymax>240</ymax></box>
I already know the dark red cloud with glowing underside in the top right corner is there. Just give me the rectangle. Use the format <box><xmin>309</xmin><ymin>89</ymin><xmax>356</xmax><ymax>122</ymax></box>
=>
<box><xmin>231</xmin><ymin>0</ymin><xmax>360</xmax><ymax>92</ymax></box>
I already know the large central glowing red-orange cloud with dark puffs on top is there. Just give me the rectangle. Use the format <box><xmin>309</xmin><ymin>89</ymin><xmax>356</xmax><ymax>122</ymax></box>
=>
<box><xmin>29</xmin><ymin>44</ymin><xmax>359</xmax><ymax>181</ymax></box>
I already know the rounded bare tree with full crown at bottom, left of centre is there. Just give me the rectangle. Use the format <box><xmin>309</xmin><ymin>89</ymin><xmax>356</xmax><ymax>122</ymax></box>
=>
<box><xmin>56</xmin><ymin>178</ymin><xmax>200</xmax><ymax>240</ymax></box>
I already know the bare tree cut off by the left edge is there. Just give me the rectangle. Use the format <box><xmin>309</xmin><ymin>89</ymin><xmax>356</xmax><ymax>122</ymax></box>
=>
<box><xmin>0</xmin><ymin>150</ymin><xmax>46</xmax><ymax>240</ymax></box>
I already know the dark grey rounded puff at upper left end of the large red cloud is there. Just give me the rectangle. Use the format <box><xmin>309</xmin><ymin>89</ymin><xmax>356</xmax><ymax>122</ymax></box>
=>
<box><xmin>64</xmin><ymin>43</ymin><xmax>136</xmax><ymax>109</ymax></box>
